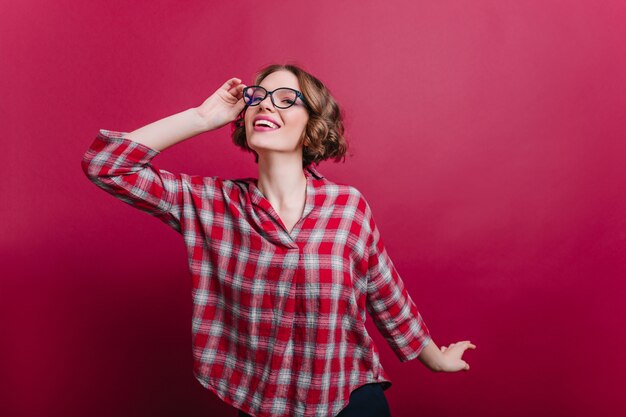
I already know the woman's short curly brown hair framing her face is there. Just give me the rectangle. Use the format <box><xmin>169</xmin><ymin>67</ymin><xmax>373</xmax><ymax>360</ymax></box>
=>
<box><xmin>232</xmin><ymin>64</ymin><xmax>348</xmax><ymax>167</ymax></box>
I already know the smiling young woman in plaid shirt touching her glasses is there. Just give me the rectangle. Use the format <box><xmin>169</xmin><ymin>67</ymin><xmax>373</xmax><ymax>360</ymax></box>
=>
<box><xmin>82</xmin><ymin>65</ymin><xmax>475</xmax><ymax>417</ymax></box>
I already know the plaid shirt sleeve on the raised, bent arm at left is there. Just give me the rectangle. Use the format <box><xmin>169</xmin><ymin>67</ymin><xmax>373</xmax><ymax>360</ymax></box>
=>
<box><xmin>81</xmin><ymin>129</ymin><xmax>182</xmax><ymax>233</ymax></box>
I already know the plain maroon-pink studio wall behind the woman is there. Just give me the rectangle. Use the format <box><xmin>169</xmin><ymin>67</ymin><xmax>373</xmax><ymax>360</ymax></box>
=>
<box><xmin>0</xmin><ymin>0</ymin><xmax>626</xmax><ymax>417</ymax></box>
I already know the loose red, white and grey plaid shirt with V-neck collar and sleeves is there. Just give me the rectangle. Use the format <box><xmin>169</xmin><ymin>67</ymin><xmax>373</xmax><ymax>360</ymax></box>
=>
<box><xmin>82</xmin><ymin>130</ymin><xmax>430</xmax><ymax>417</ymax></box>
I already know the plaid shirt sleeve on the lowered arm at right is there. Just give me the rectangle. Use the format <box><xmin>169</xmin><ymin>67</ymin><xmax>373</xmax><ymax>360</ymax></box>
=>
<box><xmin>363</xmin><ymin>195</ymin><xmax>431</xmax><ymax>362</ymax></box>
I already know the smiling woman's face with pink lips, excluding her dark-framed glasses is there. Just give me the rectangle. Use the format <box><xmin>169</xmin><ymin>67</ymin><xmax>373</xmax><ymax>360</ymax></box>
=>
<box><xmin>244</xmin><ymin>70</ymin><xmax>309</xmax><ymax>160</ymax></box>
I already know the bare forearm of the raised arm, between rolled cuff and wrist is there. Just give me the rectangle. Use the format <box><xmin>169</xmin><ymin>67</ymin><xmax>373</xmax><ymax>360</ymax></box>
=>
<box><xmin>126</xmin><ymin>108</ymin><xmax>209</xmax><ymax>152</ymax></box>
